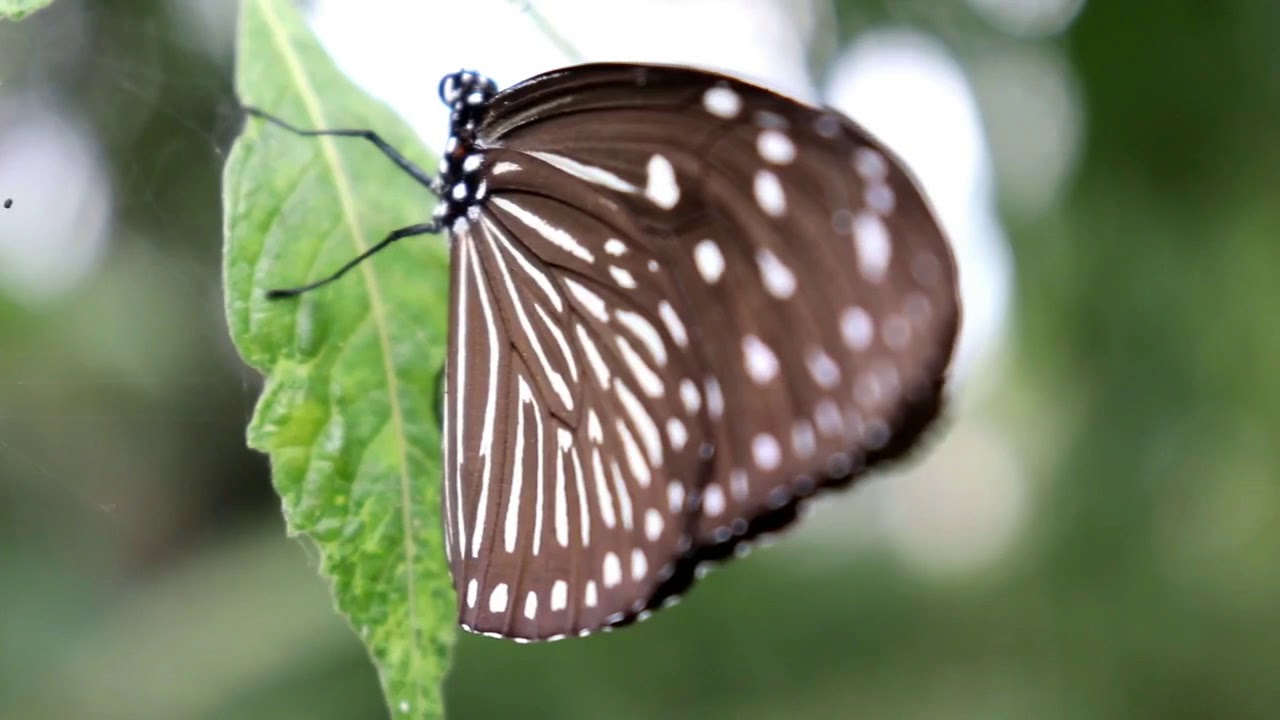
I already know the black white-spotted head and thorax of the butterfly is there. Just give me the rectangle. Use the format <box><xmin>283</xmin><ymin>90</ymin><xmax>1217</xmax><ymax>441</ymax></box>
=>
<box><xmin>435</xmin><ymin>70</ymin><xmax>498</xmax><ymax>227</ymax></box>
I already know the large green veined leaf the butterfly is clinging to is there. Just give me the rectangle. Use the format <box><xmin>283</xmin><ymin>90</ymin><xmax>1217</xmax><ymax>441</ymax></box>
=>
<box><xmin>223</xmin><ymin>0</ymin><xmax>456</xmax><ymax>717</ymax></box>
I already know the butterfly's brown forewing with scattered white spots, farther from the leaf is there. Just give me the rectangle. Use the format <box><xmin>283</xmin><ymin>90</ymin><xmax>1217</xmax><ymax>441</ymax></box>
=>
<box><xmin>481</xmin><ymin>64</ymin><xmax>959</xmax><ymax>558</ymax></box>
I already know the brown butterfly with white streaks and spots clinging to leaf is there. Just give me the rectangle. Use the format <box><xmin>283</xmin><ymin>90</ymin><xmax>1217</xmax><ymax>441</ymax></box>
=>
<box><xmin>247</xmin><ymin>63</ymin><xmax>960</xmax><ymax>641</ymax></box>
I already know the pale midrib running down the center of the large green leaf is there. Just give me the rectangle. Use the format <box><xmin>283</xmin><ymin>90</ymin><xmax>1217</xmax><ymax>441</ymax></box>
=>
<box><xmin>255</xmin><ymin>0</ymin><xmax>422</xmax><ymax>701</ymax></box>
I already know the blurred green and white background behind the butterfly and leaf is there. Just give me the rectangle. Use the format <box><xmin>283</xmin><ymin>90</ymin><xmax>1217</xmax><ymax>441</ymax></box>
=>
<box><xmin>0</xmin><ymin>0</ymin><xmax>1280</xmax><ymax>720</ymax></box>
